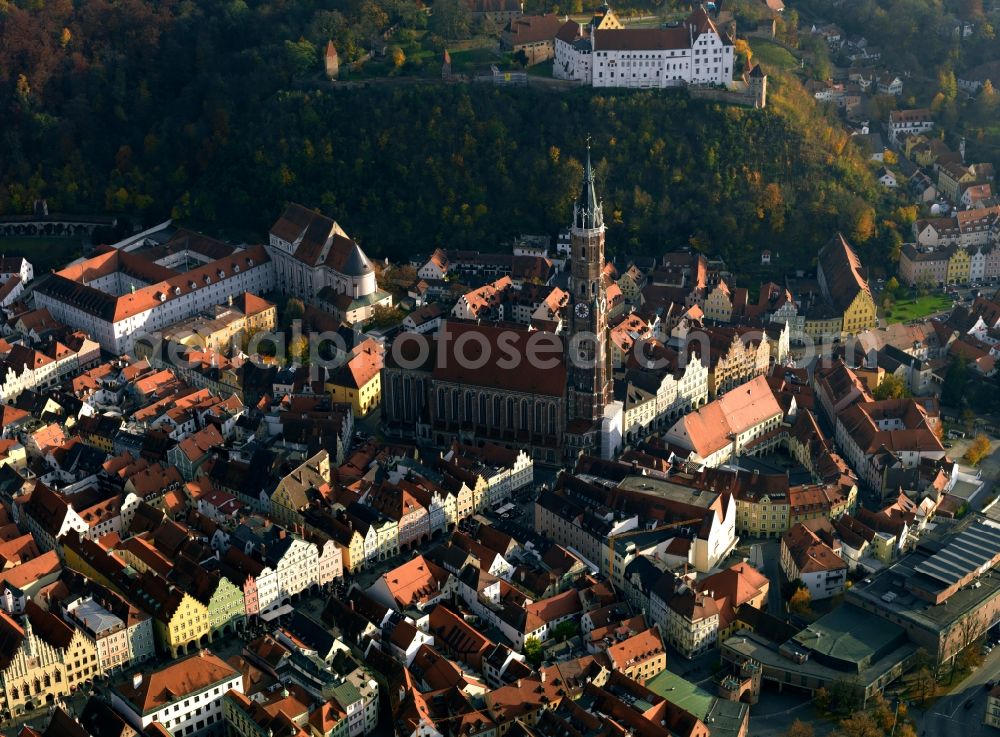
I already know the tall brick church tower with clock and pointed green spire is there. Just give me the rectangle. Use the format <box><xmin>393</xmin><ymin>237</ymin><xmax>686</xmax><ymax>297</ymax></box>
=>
<box><xmin>566</xmin><ymin>140</ymin><xmax>612</xmax><ymax>434</ymax></box>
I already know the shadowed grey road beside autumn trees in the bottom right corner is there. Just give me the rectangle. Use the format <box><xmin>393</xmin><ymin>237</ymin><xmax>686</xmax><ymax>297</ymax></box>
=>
<box><xmin>910</xmin><ymin>648</ymin><xmax>1000</xmax><ymax>737</ymax></box>
